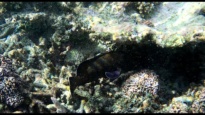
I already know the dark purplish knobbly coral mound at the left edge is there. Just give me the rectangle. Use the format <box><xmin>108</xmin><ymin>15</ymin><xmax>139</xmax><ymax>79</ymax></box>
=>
<box><xmin>0</xmin><ymin>55</ymin><xmax>24</xmax><ymax>107</ymax></box>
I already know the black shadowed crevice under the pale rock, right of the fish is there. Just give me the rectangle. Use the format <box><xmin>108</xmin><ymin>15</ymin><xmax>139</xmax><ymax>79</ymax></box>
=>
<box><xmin>113</xmin><ymin>35</ymin><xmax>205</xmax><ymax>100</ymax></box>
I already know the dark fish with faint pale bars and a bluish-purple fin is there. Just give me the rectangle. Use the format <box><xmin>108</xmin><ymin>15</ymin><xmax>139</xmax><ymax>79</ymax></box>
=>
<box><xmin>69</xmin><ymin>51</ymin><xmax>124</xmax><ymax>94</ymax></box>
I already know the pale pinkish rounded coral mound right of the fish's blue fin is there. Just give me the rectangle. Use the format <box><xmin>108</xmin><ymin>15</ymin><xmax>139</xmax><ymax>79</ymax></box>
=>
<box><xmin>122</xmin><ymin>70</ymin><xmax>158</xmax><ymax>96</ymax></box>
